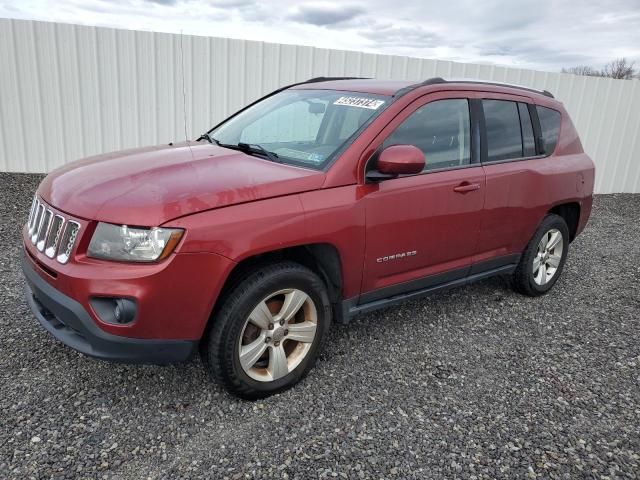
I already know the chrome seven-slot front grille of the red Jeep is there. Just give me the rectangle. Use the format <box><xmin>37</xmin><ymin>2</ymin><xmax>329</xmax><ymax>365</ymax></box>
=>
<box><xmin>27</xmin><ymin>196</ymin><xmax>80</xmax><ymax>263</ymax></box>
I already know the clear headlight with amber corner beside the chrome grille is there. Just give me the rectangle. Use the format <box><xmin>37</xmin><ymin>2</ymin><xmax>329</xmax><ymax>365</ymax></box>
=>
<box><xmin>87</xmin><ymin>222</ymin><xmax>184</xmax><ymax>262</ymax></box>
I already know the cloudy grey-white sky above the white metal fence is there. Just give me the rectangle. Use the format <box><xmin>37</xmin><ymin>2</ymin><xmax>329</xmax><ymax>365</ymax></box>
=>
<box><xmin>0</xmin><ymin>0</ymin><xmax>640</xmax><ymax>71</ymax></box>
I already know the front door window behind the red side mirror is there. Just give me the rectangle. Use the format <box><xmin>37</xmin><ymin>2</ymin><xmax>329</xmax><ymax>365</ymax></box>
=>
<box><xmin>384</xmin><ymin>99</ymin><xmax>471</xmax><ymax>171</ymax></box>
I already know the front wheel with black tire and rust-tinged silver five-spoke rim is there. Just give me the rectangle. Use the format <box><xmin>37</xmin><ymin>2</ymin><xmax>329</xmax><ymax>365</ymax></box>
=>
<box><xmin>202</xmin><ymin>262</ymin><xmax>331</xmax><ymax>400</ymax></box>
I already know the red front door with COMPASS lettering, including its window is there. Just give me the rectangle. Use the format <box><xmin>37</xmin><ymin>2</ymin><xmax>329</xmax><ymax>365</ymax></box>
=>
<box><xmin>360</xmin><ymin>92</ymin><xmax>485</xmax><ymax>303</ymax></box>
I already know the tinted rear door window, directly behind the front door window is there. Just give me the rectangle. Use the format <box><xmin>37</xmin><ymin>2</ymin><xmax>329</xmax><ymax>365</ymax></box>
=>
<box><xmin>482</xmin><ymin>100</ymin><xmax>522</xmax><ymax>162</ymax></box>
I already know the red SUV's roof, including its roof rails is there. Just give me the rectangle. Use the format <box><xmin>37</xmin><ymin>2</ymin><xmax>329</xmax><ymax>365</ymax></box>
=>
<box><xmin>292</xmin><ymin>77</ymin><xmax>554</xmax><ymax>98</ymax></box>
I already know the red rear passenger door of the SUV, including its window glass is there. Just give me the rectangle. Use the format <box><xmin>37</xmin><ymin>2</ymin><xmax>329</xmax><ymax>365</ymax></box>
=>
<box><xmin>474</xmin><ymin>93</ymin><xmax>553</xmax><ymax>266</ymax></box>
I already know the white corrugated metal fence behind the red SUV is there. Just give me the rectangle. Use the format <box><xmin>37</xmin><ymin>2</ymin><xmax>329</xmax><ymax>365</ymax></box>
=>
<box><xmin>0</xmin><ymin>19</ymin><xmax>640</xmax><ymax>193</ymax></box>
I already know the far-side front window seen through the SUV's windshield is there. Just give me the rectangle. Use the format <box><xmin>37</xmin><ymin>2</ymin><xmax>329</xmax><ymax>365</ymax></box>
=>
<box><xmin>240</xmin><ymin>100</ymin><xmax>327</xmax><ymax>144</ymax></box>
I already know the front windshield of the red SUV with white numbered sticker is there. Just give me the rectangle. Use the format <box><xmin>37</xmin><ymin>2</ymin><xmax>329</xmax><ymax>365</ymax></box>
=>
<box><xmin>209</xmin><ymin>90</ymin><xmax>389</xmax><ymax>169</ymax></box>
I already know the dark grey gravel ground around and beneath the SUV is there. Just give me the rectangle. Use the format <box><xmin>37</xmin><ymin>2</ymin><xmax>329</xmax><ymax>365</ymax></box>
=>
<box><xmin>0</xmin><ymin>174</ymin><xmax>640</xmax><ymax>479</ymax></box>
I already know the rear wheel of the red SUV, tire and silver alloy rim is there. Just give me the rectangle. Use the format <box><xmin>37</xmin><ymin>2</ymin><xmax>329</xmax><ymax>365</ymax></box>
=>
<box><xmin>513</xmin><ymin>214</ymin><xmax>569</xmax><ymax>297</ymax></box>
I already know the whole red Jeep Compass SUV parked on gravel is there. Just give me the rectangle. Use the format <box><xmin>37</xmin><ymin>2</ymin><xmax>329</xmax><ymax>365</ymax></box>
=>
<box><xmin>23</xmin><ymin>78</ymin><xmax>594</xmax><ymax>398</ymax></box>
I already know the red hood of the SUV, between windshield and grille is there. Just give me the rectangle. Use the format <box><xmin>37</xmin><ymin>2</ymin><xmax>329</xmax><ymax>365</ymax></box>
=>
<box><xmin>38</xmin><ymin>142</ymin><xmax>325</xmax><ymax>226</ymax></box>
